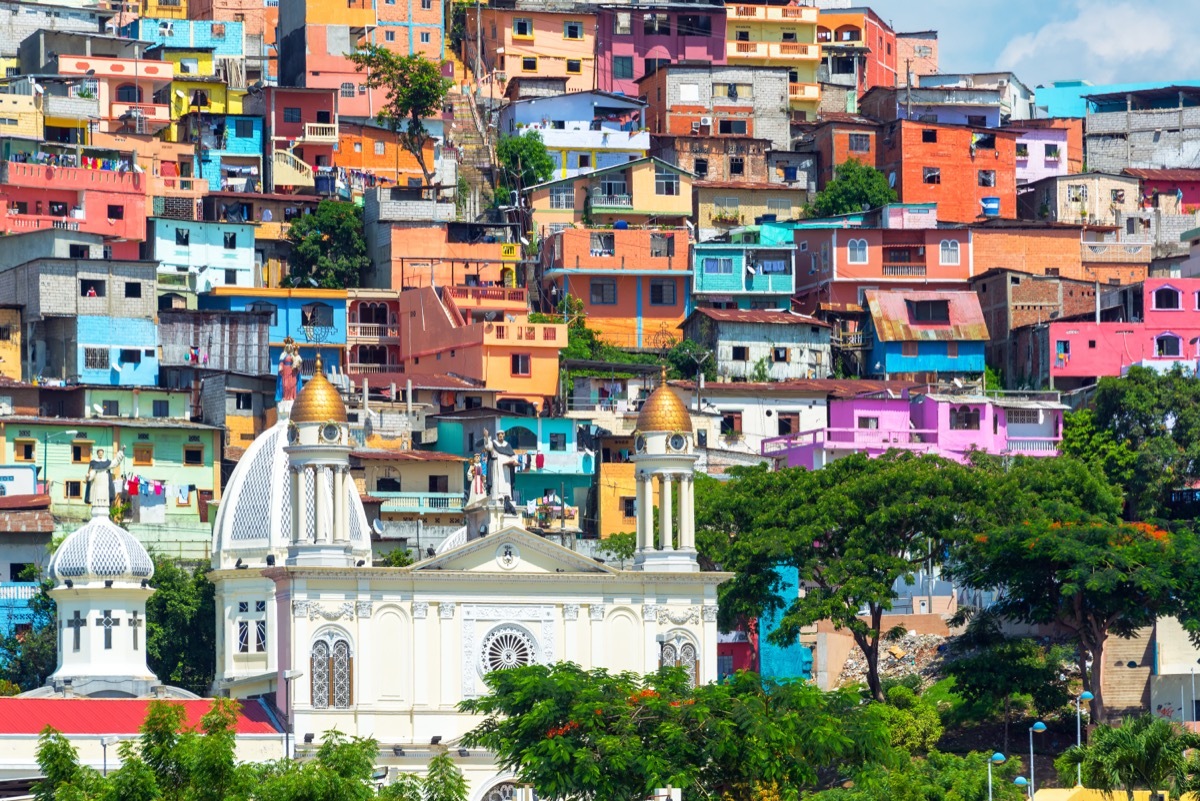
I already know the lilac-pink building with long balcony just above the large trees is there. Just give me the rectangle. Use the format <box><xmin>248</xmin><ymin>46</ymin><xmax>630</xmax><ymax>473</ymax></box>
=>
<box><xmin>762</xmin><ymin>392</ymin><xmax>1067</xmax><ymax>470</ymax></box>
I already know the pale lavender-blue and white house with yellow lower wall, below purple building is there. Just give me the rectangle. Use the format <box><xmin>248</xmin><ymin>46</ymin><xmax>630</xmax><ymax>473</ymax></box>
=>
<box><xmin>499</xmin><ymin>91</ymin><xmax>650</xmax><ymax>179</ymax></box>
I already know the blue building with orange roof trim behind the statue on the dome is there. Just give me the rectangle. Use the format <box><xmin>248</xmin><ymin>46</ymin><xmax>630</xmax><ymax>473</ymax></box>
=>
<box><xmin>198</xmin><ymin>287</ymin><xmax>346</xmax><ymax>377</ymax></box>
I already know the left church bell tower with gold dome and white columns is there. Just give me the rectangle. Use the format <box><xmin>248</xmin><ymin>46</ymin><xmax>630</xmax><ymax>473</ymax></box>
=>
<box><xmin>283</xmin><ymin>356</ymin><xmax>354</xmax><ymax>567</ymax></box>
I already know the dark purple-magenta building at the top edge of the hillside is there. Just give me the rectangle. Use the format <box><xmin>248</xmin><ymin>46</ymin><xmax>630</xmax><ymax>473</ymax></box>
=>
<box><xmin>595</xmin><ymin>2</ymin><xmax>725</xmax><ymax>97</ymax></box>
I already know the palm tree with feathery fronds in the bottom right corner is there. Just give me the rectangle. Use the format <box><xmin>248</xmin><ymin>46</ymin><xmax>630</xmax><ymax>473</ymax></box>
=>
<box><xmin>1056</xmin><ymin>715</ymin><xmax>1200</xmax><ymax>801</ymax></box>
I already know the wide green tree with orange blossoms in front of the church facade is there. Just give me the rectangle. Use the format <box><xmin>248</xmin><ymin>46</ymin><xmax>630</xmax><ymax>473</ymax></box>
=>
<box><xmin>460</xmin><ymin>663</ymin><xmax>890</xmax><ymax>801</ymax></box>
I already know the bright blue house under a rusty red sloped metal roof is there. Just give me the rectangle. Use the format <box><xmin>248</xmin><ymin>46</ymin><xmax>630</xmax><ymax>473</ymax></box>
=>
<box><xmin>864</xmin><ymin>290</ymin><xmax>988</xmax><ymax>380</ymax></box>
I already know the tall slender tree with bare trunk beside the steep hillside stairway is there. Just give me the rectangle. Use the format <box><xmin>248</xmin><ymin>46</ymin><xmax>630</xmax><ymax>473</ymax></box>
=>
<box><xmin>343</xmin><ymin>44</ymin><xmax>454</xmax><ymax>184</ymax></box>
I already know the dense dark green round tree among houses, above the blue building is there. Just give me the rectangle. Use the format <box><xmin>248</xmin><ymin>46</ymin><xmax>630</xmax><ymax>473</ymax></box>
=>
<box><xmin>288</xmin><ymin>200</ymin><xmax>371</xmax><ymax>289</ymax></box>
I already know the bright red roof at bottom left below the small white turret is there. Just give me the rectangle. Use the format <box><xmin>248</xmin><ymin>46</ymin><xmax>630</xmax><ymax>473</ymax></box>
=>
<box><xmin>0</xmin><ymin>698</ymin><xmax>280</xmax><ymax>734</ymax></box>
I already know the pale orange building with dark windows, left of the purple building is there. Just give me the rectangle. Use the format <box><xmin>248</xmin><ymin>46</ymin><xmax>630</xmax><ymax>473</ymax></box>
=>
<box><xmin>463</xmin><ymin>6</ymin><xmax>596</xmax><ymax>92</ymax></box>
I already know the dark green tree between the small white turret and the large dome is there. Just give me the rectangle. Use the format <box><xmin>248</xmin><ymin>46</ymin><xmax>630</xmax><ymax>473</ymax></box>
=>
<box><xmin>146</xmin><ymin>555</ymin><xmax>216</xmax><ymax>695</ymax></box>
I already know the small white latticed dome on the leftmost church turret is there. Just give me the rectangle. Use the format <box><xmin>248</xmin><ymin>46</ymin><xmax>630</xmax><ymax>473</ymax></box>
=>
<box><xmin>49</xmin><ymin>516</ymin><xmax>154</xmax><ymax>584</ymax></box>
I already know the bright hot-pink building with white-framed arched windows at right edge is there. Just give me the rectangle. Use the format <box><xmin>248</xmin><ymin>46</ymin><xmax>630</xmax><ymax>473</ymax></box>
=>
<box><xmin>1050</xmin><ymin>278</ymin><xmax>1200</xmax><ymax>387</ymax></box>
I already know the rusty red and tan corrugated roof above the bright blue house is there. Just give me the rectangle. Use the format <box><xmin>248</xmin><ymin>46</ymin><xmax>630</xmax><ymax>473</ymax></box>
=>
<box><xmin>863</xmin><ymin>290</ymin><xmax>989</xmax><ymax>342</ymax></box>
